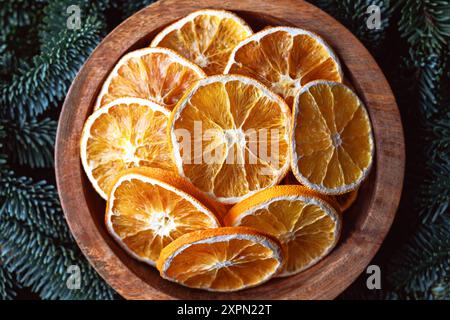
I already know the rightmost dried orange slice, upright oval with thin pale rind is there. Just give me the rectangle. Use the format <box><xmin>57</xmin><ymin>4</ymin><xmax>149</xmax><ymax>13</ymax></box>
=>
<box><xmin>291</xmin><ymin>80</ymin><xmax>374</xmax><ymax>195</ymax></box>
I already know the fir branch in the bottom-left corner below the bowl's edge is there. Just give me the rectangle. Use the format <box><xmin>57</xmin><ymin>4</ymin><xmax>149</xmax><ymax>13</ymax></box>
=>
<box><xmin>0</xmin><ymin>217</ymin><xmax>114</xmax><ymax>300</ymax></box>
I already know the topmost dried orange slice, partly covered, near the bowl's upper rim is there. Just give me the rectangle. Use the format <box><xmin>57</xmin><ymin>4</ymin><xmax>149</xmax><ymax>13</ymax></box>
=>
<box><xmin>150</xmin><ymin>10</ymin><xmax>253</xmax><ymax>75</ymax></box>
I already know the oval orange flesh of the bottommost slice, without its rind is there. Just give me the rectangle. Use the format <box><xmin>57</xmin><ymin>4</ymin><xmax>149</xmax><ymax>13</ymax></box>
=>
<box><xmin>166</xmin><ymin>239</ymin><xmax>280</xmax><ymax>291</ymax></box>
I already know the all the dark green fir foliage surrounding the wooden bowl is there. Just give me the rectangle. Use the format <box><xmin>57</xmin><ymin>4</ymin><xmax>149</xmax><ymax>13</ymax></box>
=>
<box><xmin>0</xmin><ymin>0</ymin><xmax>450</xmax><ymax>299</ymax></box>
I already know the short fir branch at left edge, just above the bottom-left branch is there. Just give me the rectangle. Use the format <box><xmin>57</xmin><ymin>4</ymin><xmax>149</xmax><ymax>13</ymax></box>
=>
<box><xmin>0</xmin><ymin>170</ymin><xmax>73</xmax><ymax>243</ymax></box>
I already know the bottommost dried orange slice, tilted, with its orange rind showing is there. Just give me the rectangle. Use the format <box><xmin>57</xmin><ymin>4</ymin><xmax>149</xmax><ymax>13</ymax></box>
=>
<box><xmin>156</xmin><ymin>227</ymin><xmax>284</xmax><ymax>292</ymax></box>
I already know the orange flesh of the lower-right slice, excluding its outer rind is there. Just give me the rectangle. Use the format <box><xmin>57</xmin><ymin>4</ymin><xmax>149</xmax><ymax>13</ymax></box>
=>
<box><xmin>239</xmin><ymin>200</ymin><xmax>336</xmax><ymax>274</ymax></box>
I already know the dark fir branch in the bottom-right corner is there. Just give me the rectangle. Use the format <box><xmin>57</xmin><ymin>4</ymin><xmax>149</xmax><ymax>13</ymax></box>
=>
<box><xmin>389</xmin><ymin>214</ymin><xmax>450</xmax><ymax>299</ymax></box>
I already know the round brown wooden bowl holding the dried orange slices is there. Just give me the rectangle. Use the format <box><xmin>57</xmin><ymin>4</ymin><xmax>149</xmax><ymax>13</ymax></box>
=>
<box><xmin>56</xmin><ymin>0</ymin><xmax>405</xmax><ymax>299</ymax></box>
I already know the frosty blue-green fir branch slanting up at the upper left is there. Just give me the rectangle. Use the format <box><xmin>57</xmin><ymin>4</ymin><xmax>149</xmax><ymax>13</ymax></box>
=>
<box><xmin>0</xmin><ymin>14</ymin><xmax>102</xmax><ymax>122</ymax></box>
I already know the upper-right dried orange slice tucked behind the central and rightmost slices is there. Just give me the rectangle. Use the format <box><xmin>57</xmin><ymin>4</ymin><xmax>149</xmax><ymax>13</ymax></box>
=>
<box><xmin>224</xmin><ymin>27</ymin><xmax>342</xmax><ymax>106</ymax></box>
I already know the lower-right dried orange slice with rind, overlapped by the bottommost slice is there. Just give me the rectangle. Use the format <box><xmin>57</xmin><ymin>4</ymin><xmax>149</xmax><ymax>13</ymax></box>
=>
<box><xmin>224</xmin><ymin>186</ymin><xmax>341</xmax><ymax>276</ymax></box>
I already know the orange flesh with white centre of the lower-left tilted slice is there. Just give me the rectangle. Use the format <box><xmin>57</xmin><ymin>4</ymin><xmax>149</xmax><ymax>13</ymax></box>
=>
<box><xmin>111</xmin><ymin>179</ymin><xmax>217</xmax><ymax>262</ymax></box>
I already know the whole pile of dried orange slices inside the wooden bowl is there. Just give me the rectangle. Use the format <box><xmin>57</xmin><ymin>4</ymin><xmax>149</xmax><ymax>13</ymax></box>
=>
<box><xmin>80</xmin><ymin>10</ymin><xmax>374</xmax><ymax>292</ymax></box>
